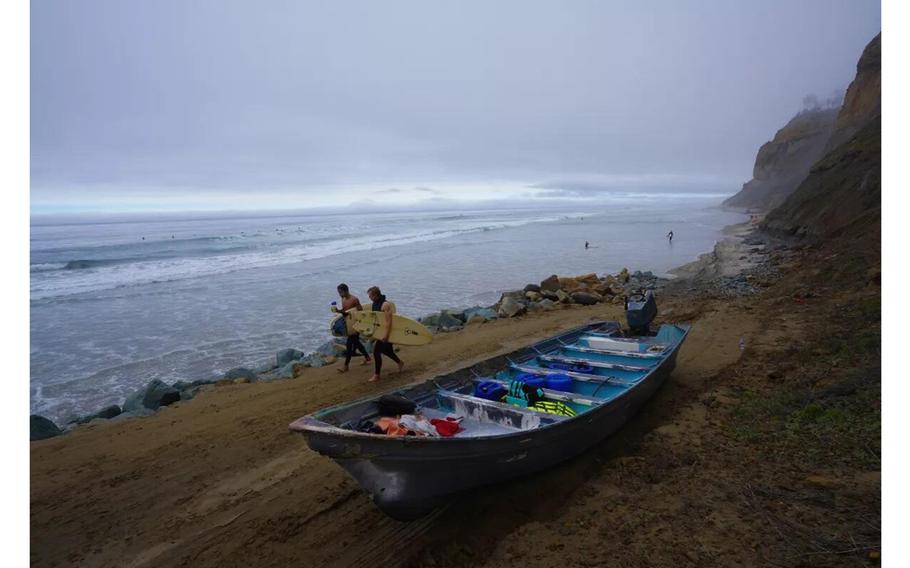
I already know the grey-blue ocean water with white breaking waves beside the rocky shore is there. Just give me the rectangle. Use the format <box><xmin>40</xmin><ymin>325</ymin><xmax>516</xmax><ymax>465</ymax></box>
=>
<box><xmin>30</xmin><ymin>194</ymin><xmax>742</xmax><ymax>421</ymax></box>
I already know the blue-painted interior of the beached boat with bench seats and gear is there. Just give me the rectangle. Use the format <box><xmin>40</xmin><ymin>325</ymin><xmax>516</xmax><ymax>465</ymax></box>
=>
<box><xmin>311</xmin><ymin>322</ymin><xmax>687</xmax><ymax>439</ymax></box>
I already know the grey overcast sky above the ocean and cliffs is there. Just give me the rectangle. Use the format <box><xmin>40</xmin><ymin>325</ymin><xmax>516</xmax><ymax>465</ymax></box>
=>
<box><xmin>31</xmin><ymin>0</ymin><xmax>881</xmax><ymax>213</ymax></box>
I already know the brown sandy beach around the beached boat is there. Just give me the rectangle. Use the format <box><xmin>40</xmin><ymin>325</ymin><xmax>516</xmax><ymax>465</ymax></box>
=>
<box><xmin>31</xmin><ymin>224</ymin><xmax>879</xmax><ymax>567</ymax></box>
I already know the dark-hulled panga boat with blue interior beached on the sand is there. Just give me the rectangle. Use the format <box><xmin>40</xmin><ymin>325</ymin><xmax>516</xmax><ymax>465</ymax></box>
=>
<box><xmin>290</xmin><ymin>316</ymin><xmax>689</xmax><ymax>520</ymax></box>
